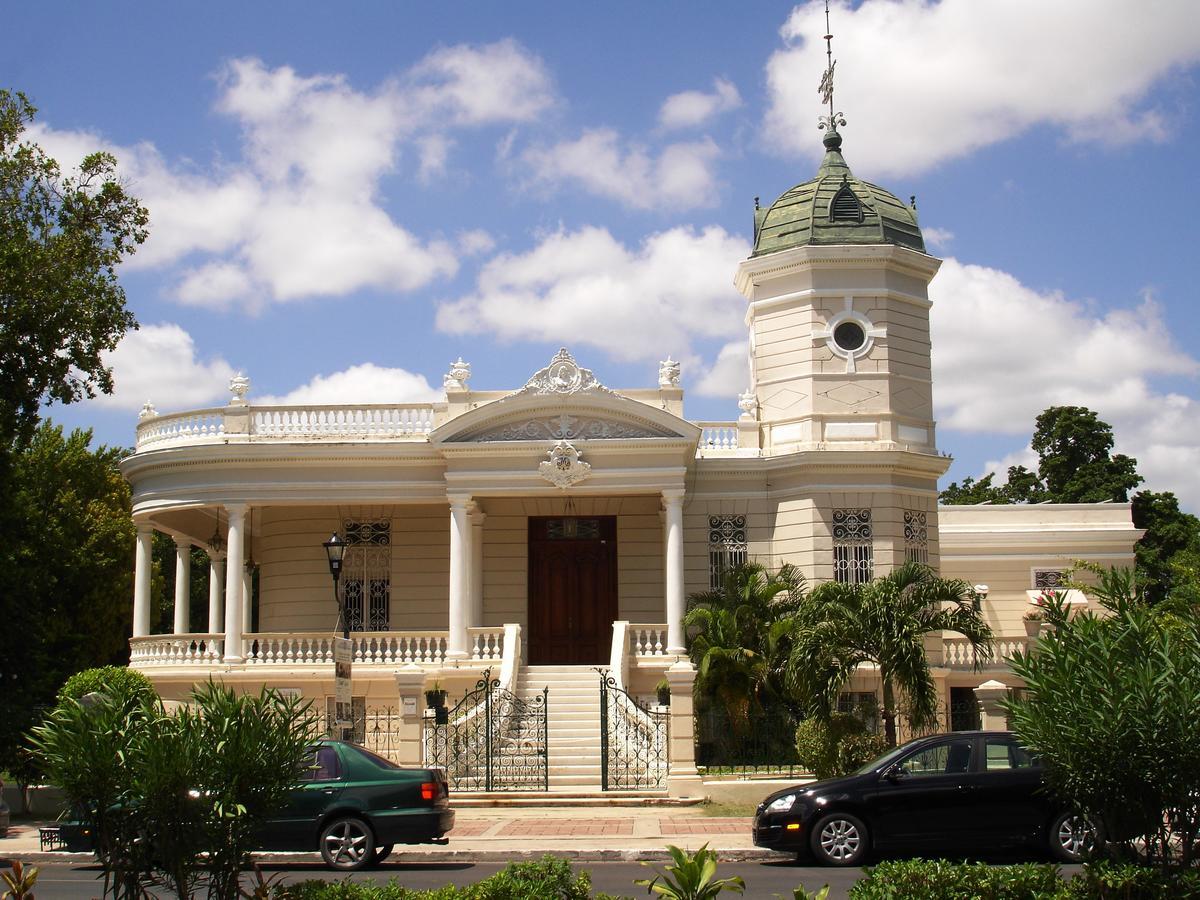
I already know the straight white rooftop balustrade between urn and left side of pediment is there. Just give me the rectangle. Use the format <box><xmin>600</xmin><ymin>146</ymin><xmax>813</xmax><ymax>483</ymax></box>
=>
<box><xmin>251</xmin><ymin>403</ymin><xmax>433</xmax><ymax>439</ymax></box>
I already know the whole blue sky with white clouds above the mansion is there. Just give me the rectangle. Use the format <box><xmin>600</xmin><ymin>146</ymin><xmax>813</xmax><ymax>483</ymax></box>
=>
<box><xmin>9</xmin><ymin>0</ymin><xmax>1200</xmax><ymax>510</ymax></box>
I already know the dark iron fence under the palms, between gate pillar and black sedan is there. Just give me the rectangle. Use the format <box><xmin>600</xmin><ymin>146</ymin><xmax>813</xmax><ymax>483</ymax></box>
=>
<box><xmin>696</xmin><ymin>707</ymin><xmax>804</xmax><ymax>776</ymax></box>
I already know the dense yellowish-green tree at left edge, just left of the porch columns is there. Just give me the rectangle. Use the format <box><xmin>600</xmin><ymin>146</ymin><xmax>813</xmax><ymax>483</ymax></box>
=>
<box><xmin>0</xmin><ymin>422</ymin><xmax>134</xmax><ymax>767</ymax></box>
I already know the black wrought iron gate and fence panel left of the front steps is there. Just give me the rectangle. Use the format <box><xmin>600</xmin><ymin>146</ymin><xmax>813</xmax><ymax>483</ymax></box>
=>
<box><xmin>425</xmin><ymin>670</ymin><xmax>550</xmax><ymax>791</ymax></box>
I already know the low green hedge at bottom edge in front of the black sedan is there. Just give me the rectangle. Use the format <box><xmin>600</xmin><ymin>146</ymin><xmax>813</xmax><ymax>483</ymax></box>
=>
<box><xmin>850</xmin><ymin>859</ymin><xmax>1065</xmax><ymax>900</ymax></box>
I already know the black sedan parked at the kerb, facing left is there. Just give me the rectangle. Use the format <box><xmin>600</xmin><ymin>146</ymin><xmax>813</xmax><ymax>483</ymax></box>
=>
<box><xmin>754</xmin><ymin>731</ymin><xmax>1093</xmax><ymax>865</ymax></box>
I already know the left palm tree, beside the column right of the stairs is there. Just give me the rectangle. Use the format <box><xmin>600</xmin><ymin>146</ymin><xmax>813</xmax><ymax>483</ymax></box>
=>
<box><xmin>683</xmin><ymin>563</ymin><xmax>805</xmax><ymax>727</ymax></box>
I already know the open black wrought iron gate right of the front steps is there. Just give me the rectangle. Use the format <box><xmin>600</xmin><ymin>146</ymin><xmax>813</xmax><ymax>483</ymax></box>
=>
<box><xmin>598</xmin><ymin>670</ymin><xmax>668</xmax><ymax>791</ymax></box>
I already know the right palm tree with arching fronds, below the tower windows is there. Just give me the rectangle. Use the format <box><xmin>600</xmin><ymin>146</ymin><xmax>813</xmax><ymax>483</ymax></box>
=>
<box><xmin>785</xmin><ymin>563</ymin><xmax>992</xmax><ymax>745</ymax></box>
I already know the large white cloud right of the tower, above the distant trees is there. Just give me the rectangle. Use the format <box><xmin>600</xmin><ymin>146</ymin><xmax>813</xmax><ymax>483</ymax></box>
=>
<box><xmin>930</xmin><ymin>259</ymin><xmax>1200</xmax><ymax>508</ymax></box>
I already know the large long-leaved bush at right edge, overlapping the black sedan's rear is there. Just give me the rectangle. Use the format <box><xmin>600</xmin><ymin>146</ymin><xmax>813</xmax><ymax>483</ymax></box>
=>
<box><xmin>1007</xmin><ymin>570</ymin><xmax>1200</xmax><ymax>866</ymax></box>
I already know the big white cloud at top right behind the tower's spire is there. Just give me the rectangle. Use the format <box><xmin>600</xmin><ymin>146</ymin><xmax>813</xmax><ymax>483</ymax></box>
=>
<box><xmin>767</xmin><ymin>0</ymin><xmax>1200</xmax><ymax>176</ymax></box>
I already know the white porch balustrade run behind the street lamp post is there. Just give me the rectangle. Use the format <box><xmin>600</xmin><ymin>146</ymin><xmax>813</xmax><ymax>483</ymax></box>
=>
<box><xmin>245</xmin><ymin>631</ymin><xmax>446</xmax><ymax>666</ymax></box>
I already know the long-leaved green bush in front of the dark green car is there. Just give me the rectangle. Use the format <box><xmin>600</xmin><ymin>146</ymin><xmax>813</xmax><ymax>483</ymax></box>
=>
<box><xmin>34</xmin><ymin>682</ymin><xmax>316</xmax><ymax>900</ymax></box>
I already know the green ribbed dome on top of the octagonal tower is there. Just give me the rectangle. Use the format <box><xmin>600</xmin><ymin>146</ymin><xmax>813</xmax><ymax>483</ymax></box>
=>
<box><xmin>750</xmin><ymin>128</ymin><xmax>925</xmax><ymax>257</ymax></box>
